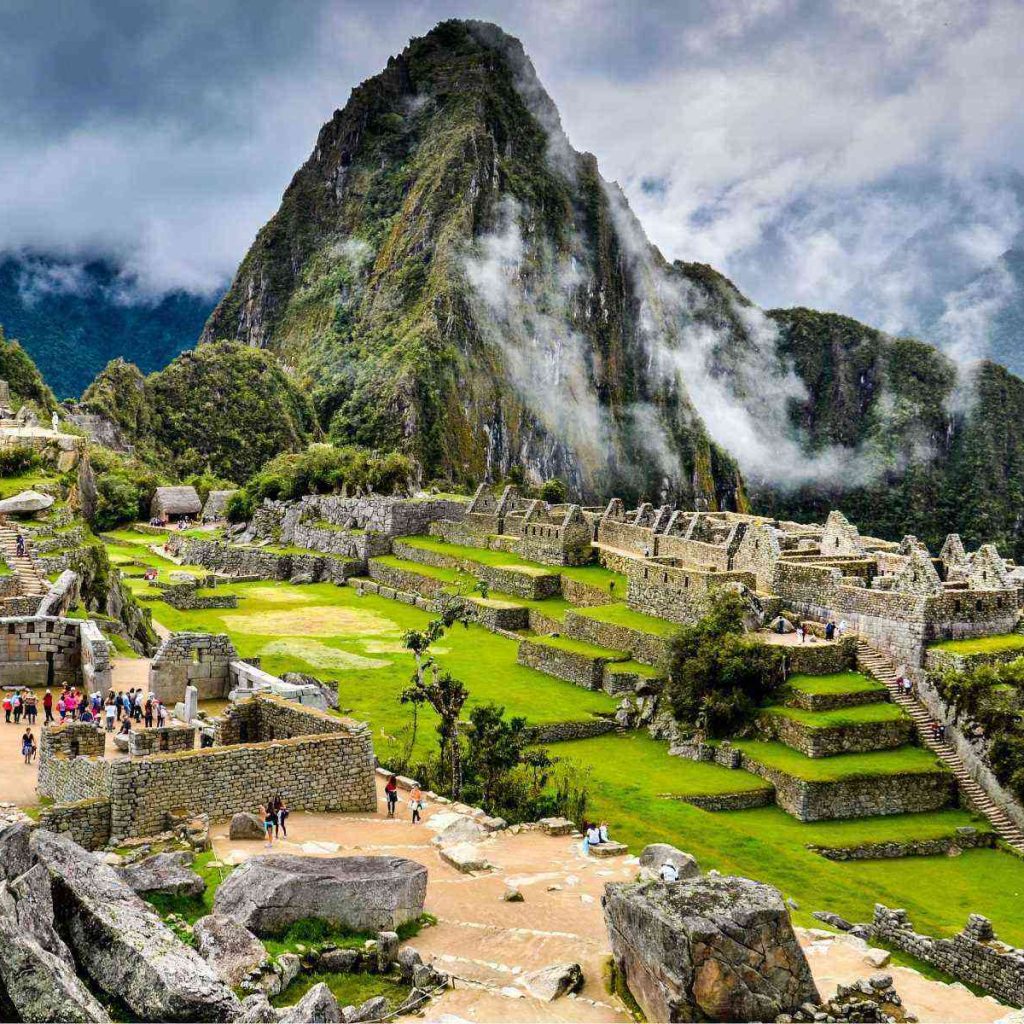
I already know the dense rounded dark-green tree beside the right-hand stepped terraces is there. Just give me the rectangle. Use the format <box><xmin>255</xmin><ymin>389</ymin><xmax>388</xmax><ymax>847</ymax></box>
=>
<box><xmin>668</xmin><ymin>590</ymin><xmax>784</xmax><ymax>739</ymax></box>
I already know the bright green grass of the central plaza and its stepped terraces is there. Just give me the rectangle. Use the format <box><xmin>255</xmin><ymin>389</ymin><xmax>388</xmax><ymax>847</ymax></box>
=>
<box><xmin>94</xmin><ymin>534</ymin><xmax>1024</xmax><ymax>942</ymax></box>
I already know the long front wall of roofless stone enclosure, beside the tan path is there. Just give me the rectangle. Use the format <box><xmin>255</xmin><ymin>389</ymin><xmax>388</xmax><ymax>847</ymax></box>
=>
<box><xmin>111</xmin><ymin>697</ymin><xmax>377</xmax><ymax>841</ymax></box>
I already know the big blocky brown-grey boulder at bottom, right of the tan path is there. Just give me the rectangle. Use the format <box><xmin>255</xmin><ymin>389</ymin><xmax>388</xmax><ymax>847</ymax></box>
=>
<box><xmin>603</xmin><ymin>876</ymin><xmax>820</xmax><ymax>1021</ymax></box>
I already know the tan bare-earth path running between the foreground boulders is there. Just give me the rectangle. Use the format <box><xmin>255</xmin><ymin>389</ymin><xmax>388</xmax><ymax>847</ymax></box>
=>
<box><xmin>207</xmin><ymin>778</ymin><xmax>1008</xmax><ymax>1024</ymax></box>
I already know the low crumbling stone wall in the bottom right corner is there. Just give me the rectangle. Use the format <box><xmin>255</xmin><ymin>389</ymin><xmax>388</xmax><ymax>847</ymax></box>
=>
<box><xmin>871</xmin><ymin>903</ymin><xmax>1024</xmax><ymax>1007</ymax></box>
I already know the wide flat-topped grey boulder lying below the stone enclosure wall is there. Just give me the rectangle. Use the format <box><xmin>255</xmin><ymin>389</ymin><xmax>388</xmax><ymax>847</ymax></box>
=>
<box><xmin>213</xmin><ymin>854</ymin><xmax>427</xmax><ymax>935</ymax></box>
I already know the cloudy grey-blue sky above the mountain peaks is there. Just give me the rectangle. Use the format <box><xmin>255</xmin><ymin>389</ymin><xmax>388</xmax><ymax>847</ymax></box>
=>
<box><xmin>0</xmin><ymin>0</ymin><xmax>1024</xmax><ymax>344</ymax></box>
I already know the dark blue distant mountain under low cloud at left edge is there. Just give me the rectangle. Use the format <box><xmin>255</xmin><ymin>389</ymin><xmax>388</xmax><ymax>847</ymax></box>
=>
<box><xmin>0</xmin><ymin>254</ymin><xmax>214</xmax><ymax>398</ymax></box>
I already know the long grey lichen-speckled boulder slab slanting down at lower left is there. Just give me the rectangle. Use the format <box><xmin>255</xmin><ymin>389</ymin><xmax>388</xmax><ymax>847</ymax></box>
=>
<box><xmin>29</xmin><ymin>829</ymin><xmax>241</xmax><ymax>1021</ymax></box>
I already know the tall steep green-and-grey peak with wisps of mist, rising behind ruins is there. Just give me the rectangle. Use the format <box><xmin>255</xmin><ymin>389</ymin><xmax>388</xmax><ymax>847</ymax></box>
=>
<box><xmin>203</xmin><ymin>22</ymin><xmax>744</xmax><ymax>508</ymax></box>
